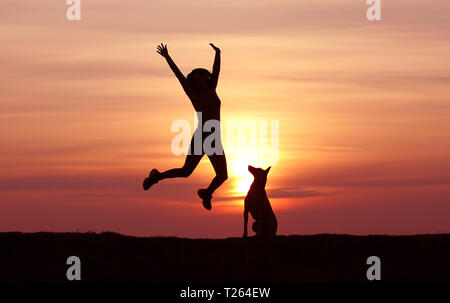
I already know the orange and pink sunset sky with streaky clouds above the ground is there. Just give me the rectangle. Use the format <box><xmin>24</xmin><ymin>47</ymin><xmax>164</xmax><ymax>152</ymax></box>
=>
<box><xmin>0</xmin><ymin>0</ymin><xmax>450</xmax><ymax>238</ymax></box>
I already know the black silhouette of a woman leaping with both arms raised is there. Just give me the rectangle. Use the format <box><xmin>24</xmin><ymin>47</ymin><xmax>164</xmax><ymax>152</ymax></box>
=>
<box><xmin>143</xmin><ymin>43</ymin><xmax>228</xmax><ymax>210</ymax></box>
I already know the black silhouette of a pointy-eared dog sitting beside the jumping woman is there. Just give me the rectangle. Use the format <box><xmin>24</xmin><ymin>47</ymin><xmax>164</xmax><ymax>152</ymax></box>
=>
<box><xmin>243</xmin><ymin>165</ymin><xmax>278</xmax><ymax>238</ymax></box>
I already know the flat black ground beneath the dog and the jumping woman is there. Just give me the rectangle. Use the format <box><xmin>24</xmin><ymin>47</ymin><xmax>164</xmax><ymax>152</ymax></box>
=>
<box><xmin>0</xmin><ymin>232</ymin><xmax>450</xmax><ymax>283</ymax></box>
